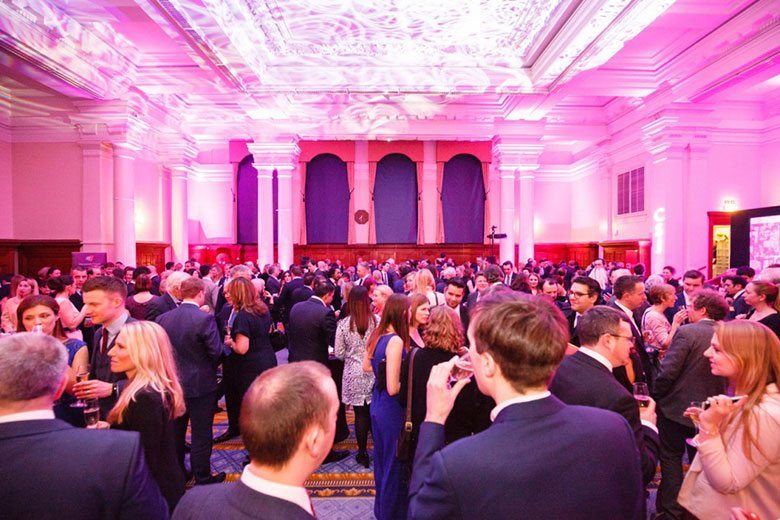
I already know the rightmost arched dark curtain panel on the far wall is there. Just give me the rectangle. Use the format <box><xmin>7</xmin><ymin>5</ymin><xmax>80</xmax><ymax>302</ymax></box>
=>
<box><xmin>441</xmin><ymin>154</ymin><xmax>485</xmax><ymax>244</ymax></box>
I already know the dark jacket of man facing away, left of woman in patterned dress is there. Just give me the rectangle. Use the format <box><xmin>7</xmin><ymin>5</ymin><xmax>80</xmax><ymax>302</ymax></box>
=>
<box><xmin>287</xmin><ymin>297</ymin><xmax>336</xmax><ymax>364</ymax></box>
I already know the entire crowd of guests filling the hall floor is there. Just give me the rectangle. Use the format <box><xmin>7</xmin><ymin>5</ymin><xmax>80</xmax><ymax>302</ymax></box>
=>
<box><xmin>0</xmin><ymin>255</ymin><xmax>780</xmax><ymax>520</ymax></box>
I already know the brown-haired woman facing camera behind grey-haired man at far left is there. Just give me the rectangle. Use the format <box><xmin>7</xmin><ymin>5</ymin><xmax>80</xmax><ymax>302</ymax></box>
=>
<box><xmin>16</xmin><ymin>294</ymin><xmax>89</xmax><ymax>426</ymax></box>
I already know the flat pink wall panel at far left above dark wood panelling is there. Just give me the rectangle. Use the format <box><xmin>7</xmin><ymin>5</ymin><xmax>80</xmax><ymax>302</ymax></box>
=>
<box><xmin>12</xmin><ymin>143</ymin><xmax>83</xmax><ymax>240</ymax></box>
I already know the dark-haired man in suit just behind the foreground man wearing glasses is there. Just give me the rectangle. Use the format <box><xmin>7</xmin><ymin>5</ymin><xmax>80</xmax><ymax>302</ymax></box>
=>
<box><xmin>607</xmin><ymin>275</ymin><xmax>654</xmax><ymax>392</ymax></box>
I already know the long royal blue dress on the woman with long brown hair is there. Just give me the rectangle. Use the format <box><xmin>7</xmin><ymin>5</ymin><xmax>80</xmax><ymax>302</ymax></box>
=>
<box><xmin>370</xmin><ymin>334</ymin><xmax>409</xmax><ymax>520</ymax></box>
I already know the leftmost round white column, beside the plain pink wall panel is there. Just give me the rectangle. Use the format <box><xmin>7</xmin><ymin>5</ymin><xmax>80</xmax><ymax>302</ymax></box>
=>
<box><xmin>113</xmin><ymin>144</ymin><xmax>136</xmax><ymax>265</ymax></box>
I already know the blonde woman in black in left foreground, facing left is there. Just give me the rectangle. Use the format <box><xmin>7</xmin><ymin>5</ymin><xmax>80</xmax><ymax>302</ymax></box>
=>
<box><xmin>100</xmin><ymin>321</ymin><xmax>185</xmax><ymax>511</ymax></box>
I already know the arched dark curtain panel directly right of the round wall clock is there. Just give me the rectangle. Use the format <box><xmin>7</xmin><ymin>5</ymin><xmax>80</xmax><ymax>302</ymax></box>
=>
<box><xmin>374</xmin><ymin>153</ymin><xmax>417</xmax><ymax>244</ymax></box>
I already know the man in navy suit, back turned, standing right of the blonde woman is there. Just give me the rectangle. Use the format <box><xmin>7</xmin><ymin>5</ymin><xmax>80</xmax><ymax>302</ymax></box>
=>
<box><xmin>157</xmin><ymin>278</ymin><xmax>225</xmax><ymax>484</ymax></box>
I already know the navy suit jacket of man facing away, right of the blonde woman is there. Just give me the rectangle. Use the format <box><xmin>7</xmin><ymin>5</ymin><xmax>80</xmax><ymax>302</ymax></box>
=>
<box><xmin>157</xmin><ymin>303</ymin><xmax>222</xmax><ymax>398</ymax></box>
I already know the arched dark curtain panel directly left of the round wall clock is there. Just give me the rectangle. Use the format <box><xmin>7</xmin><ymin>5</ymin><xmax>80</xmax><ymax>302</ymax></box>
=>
<box><xmin>306</xmin><ymin>154</ymin><xmax>350</xmax><ymax>244</ymax></box>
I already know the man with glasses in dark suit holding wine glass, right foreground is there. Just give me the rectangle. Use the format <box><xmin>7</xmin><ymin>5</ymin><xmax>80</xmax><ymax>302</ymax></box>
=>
<box><xmin>550</xmin><ymin>305</ymin><xmax>659</xmax><ymax>485</ymax></box>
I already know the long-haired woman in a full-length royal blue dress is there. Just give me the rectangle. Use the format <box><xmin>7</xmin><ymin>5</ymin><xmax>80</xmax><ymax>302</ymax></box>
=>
<box><xmin>366</xmin><ymin>289</ymin><xmax>409</xmax><ymax>520</ymax></box>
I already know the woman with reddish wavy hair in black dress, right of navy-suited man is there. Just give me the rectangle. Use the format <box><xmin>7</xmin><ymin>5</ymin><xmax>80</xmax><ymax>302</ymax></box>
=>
<box><xmin>220</xmin><ymin>277</ymin><xmax>276</xmax><ymax>439</ymax></box>
